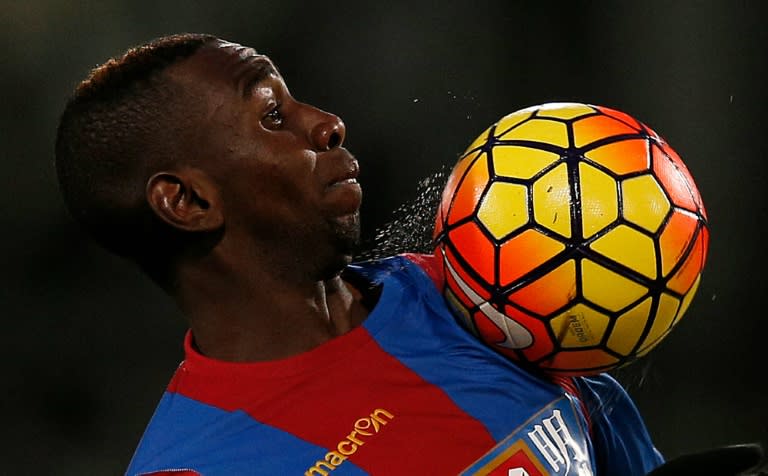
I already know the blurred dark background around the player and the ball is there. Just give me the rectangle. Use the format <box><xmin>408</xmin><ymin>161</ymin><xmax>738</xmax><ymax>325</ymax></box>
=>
<box><xmin>0</xmin><ymin>0</ymin><xmax>768</xmax><ymax>475</ymax></box>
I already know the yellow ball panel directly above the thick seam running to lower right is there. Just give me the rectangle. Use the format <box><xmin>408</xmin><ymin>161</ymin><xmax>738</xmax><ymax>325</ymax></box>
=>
<box><xmin>589</xmin><ymin>225</ymin><xmax>656</xmax><ymax>279</ymax></box>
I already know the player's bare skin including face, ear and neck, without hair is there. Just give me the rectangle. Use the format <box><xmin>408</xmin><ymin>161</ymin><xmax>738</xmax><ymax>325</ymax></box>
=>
<box><xmin>146</xmin><ymin>41</ymin><xmax>368</xmax><ymax>361</ymax></box>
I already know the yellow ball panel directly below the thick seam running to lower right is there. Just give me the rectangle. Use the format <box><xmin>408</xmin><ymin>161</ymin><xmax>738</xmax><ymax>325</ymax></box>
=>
<box><xmin>581</xmin><ymin>259</ymin><xmax>648</xmax><ymax>312</ymax></box>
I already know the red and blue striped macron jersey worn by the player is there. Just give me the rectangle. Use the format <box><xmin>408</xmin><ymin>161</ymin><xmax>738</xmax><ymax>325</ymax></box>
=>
<box><xmin>127</xmin><ymin>256</ymin><xmax>661</xmax><ymax>476</ymax></box>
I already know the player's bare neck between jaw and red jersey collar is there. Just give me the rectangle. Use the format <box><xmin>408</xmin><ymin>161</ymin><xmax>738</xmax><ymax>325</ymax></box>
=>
<box><xmin>174</xmin><ymin>245</ymin><xmax>367</xmax><ymax>361</ymax></box>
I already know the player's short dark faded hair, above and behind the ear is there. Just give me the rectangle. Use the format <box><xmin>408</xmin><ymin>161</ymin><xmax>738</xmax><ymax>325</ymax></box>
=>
<box><xmin>56</xmin><ymin>34</ymin><xmax>217</xmax><ymax>276</ymax></box>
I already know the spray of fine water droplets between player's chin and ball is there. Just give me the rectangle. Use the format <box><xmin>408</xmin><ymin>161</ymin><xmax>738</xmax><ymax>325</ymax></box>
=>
<box><xmin>356</xmin><ymin>165</ymin><xmax>451</xmax><ymax>261</ymax></box>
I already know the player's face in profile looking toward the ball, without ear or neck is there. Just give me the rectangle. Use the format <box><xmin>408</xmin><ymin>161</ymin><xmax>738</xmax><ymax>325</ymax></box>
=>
<box><xmin>170</xmin><ymin>41</ymin><xmax>362</xmax><ymax>278</ymax></box>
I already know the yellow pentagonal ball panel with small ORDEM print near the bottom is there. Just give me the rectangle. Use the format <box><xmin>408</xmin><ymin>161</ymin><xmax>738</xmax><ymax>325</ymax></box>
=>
<box><xmin>549</xmin><ymin>304</ymin><xmax>610</xmax><ymax>349</ymax></box>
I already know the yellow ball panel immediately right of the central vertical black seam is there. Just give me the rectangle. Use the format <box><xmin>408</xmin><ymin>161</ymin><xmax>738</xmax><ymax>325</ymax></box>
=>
<box><xmin>579</xmin><ymin>162</ymin><xmax>619</xmax><ymax>238</ymax></box>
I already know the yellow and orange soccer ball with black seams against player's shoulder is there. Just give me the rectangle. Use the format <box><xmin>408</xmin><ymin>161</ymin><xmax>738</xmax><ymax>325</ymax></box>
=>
<box><xmin>434</xmin><ymin>103</ymin><xmax>709</xmax><ymax>375</ymax></box>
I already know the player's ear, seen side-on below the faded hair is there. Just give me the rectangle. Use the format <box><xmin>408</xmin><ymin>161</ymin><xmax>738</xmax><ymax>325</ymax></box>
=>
<box><xmin>146</xmin><ymin>168</ymin><xmax>224</xmax><ymax>231</ymax></box>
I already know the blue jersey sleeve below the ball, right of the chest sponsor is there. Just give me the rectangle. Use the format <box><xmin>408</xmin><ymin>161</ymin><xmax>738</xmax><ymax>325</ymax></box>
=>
<box><xmin>574</xmin><ymin>374</ymin><xmax>664</xmax><ymax>476</ymax></box>
